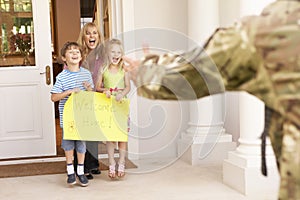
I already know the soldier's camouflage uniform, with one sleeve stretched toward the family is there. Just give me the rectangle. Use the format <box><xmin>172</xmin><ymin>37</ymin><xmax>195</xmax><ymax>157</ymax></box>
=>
<box><xmin>136</xmin><ymin>0</ymin><xmax>300</xmax><ymax>200</ymax></box>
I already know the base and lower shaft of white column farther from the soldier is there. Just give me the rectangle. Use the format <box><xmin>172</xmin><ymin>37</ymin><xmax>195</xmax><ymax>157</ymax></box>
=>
<box><xmin>178</xmin><ymin>94</ymin><xmax>236</xmax><ymax>165</ymax></box>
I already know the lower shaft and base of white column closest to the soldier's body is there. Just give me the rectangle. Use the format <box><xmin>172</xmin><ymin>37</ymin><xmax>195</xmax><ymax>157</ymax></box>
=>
<box><xmin>223</xmin><ymin>92</ymin><xmax>279</xmax><ymax>199</ymax></box>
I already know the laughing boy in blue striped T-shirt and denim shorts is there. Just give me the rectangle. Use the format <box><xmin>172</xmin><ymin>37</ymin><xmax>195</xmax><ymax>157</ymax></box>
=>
<box><xmin>51</xmin><ymin>42</ymin><xmax>94</xmax><ymax>186</ymax></box>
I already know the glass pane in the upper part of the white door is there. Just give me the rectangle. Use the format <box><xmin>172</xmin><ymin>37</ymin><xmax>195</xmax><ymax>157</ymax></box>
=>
<box><xmin>0</xmin><ymin>0</ymin><xmax>35</xmax><ymax>67</ymax></box>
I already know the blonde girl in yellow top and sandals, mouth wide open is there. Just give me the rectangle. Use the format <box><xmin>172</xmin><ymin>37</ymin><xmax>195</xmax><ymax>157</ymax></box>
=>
<box><xmin>96</xmin><ymin>39</ymin><xmax>130</xmax><ymax>179</ymax></box>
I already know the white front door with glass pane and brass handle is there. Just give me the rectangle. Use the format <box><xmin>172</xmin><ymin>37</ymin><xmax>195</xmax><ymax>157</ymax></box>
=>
<box><xmin>0</xmin><ymin>0</ymin><xmax>56</xmax><ymax>159</ymax></box>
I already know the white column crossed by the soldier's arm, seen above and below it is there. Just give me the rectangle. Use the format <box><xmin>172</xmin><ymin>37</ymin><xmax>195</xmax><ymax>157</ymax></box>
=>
<box><xmin>178</xmin><ymin>0</ymin><xmax>236</xmax><ymax>165</ymax></box>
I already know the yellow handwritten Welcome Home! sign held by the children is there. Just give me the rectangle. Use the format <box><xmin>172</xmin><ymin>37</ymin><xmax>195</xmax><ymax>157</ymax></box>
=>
<box><xmin>63</xmin><ymin>91</ymin><xmax>129</xmax><ymax>142</ymax></box>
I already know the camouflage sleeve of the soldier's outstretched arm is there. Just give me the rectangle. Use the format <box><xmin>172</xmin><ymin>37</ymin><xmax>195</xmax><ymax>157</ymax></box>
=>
<box><xmin>132</xmin><ymin>26</ymin><xmax>256</xmax><ymax>100</ymax></box>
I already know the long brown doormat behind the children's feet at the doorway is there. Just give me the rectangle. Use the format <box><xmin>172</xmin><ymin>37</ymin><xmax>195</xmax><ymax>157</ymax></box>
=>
<box><xmin>0</xmin><ymin>158</ymin><xmax>137</xmax><ymax>178</ymax></box>
